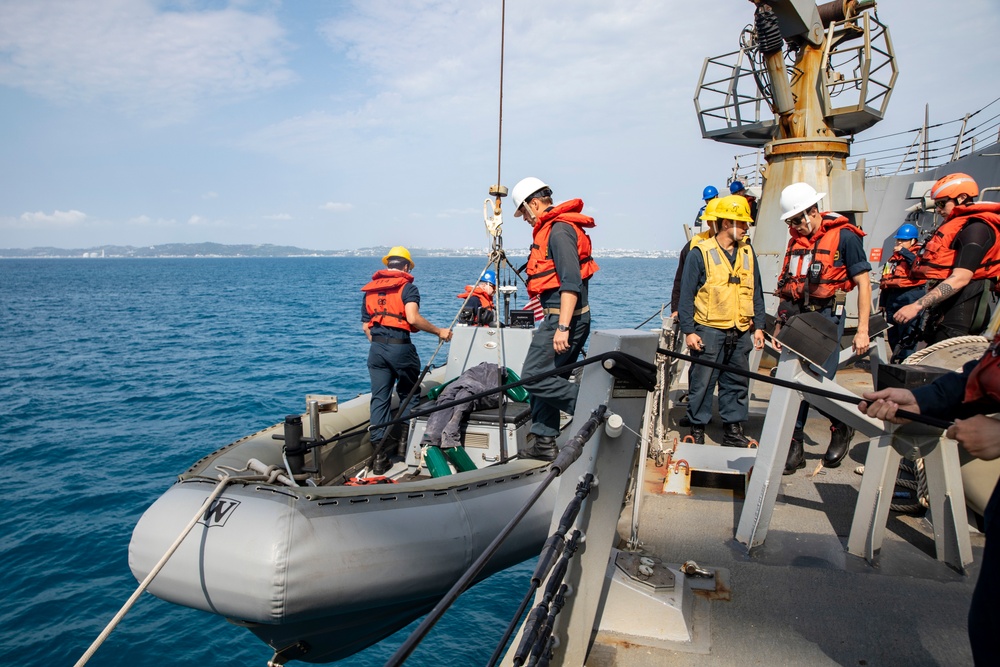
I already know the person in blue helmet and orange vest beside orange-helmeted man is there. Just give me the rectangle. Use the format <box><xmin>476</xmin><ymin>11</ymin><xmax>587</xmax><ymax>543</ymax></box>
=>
<box><xmin>878</xmin><ymin>222</ymin><xmax>927</xmax><ymax>364</ymax></box>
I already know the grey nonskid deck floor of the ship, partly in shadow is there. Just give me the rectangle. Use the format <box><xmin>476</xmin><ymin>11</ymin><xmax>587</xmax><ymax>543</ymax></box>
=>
<box><xmin>600</xmin><ymin>371</ymin><xmax>984</xmax><ymax>667</ymax></box>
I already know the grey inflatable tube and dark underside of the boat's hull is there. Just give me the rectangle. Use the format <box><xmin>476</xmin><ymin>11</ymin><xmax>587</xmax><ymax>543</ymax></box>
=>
<box><xmin>129</xmin><ymin>460</ymin><xmax>555</xmax><ymax>662</ymax></box>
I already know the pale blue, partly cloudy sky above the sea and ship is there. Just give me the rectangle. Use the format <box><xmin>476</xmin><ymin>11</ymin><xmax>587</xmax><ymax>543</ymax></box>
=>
<box><xmin>0</xmin><ymin>0</ymin><xmax>1000</xmax><ymax>250</ymax></box>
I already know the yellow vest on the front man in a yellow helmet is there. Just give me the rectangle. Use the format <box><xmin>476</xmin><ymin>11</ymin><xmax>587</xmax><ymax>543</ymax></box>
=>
<box><xmin>694</xmin><ymin>237</ymin><xmax>754</xmax><ymax>331</ymax></box>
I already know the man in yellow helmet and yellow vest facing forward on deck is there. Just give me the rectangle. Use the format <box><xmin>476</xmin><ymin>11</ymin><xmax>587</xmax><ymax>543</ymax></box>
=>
<box><xmin>678</xmin><ymin>195</ymin><xmax>764</xmax><ymax>447</ymax></box>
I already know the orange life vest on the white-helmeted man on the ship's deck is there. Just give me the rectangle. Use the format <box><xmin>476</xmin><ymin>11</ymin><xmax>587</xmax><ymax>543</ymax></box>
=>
<box><xmin>776</xmin><ymin>212</ymin><xmax>865</xmax><ymax>301</ymax></box>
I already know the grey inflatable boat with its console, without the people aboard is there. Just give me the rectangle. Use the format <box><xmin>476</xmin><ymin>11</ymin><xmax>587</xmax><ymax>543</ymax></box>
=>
<box><xmin>129</xmin><ymin>327</ymin><xmax>557</xmax><ymax>664</ymax></box>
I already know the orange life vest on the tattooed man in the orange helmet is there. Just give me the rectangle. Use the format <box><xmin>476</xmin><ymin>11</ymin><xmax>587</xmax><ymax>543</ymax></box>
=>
<box><xmin>913</xmin><ymin>202</ymin><xmax>1000</xmax><ymax>280</ymax></box>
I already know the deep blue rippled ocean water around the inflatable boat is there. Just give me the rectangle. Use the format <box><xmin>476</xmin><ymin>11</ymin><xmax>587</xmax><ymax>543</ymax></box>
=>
<box><xmin>0</xmin><ymin>258</ymin><xmax>676</xmax><ymax>667</ymax></box>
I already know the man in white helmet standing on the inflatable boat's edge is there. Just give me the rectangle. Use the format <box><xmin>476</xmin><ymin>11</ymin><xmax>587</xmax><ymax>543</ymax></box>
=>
<box><xmin>511</xmin><ymin>177</ymin><xmax>598</xmax><ymax>461</ymax></box>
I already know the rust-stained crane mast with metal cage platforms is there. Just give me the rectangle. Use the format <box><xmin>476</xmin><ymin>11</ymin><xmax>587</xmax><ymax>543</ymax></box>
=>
<box><xmin>695</xmin><ymin>0</ymin><xmax>897</xmax><ymax>312</ymax></box>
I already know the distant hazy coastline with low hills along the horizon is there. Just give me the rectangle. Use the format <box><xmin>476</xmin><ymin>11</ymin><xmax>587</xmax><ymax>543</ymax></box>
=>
<box><xmin>0</xmin><ymin>243</ymin><xmax>679</xmax><ymax>259</ymax></box>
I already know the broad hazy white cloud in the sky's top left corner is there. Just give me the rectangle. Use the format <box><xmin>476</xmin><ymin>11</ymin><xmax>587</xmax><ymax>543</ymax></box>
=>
<box><xmin>0</xmin><ymin>0</ymin><xmax>295</xmax><ymax>123</ymax></box>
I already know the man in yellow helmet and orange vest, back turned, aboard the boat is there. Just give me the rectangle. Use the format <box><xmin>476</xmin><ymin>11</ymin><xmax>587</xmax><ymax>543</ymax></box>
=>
<box><xmin>361</xmin><ymin>246</ymin><xmax>451</xmax><ymax>475</ymax></box>
